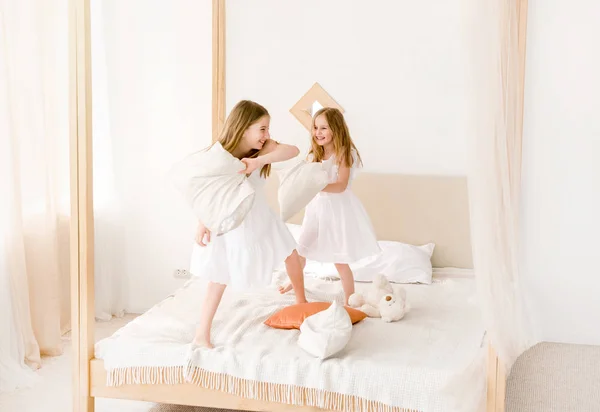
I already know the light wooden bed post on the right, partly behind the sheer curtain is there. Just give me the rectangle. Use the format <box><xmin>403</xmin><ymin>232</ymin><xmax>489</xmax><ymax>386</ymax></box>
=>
<box><xmin>487</xmin><ymin>0</ymin><xmax>528</xmax><ymax>412</ymax></box>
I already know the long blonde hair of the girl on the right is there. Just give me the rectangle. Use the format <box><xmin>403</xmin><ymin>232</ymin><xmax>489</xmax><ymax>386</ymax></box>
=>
<box><xmin>308</xmin><ymin>107</ymin><xmax>362</xmax><ymax>167</ymax></box>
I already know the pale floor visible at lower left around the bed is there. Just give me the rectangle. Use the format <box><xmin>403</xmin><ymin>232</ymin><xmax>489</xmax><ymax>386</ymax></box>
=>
<box><xmin>0</xmin><ymin>315</ymin><xmax>238</xmax><ymax>412</ymax></box>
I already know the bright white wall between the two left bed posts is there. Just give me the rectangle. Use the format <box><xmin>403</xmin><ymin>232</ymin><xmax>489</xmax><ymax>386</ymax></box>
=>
<box><xmin>92</xmin><ymin>0</ymin><xmax>212</xmax><ymax>312</ymax></box>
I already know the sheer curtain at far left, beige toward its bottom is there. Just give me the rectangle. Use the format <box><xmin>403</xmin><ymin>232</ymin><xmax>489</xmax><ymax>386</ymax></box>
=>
<box><xmin>0</xmin><ymin>0</ymin><xmax>70</xmax><ymax>390</ymax></box>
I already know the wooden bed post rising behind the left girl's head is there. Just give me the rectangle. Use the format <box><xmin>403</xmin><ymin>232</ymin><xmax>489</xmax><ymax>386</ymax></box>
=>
<box><xmin>212</xmin><ymin>0</ymin><xmax>225</xmax><ymax>142</ymax></box>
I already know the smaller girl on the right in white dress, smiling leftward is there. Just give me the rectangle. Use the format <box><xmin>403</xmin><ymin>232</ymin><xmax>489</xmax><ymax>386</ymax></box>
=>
<box><xmin>280</xmin><ymin>107</ymin><xmax>381</xmax><ymax>304</ymax></box>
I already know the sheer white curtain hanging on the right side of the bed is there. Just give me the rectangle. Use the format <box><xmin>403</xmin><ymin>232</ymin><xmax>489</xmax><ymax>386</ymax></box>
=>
<box><xmin>464</xmin><ymin>0</ymin><xmax>533</xmax><ymax>371</ymax></box>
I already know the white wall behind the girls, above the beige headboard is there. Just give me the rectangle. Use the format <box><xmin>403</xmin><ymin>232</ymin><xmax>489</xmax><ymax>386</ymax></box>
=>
<box><xmin>226</xmin><ymin>0</ymin><xmax>468</xmax><ymax>175</ymax></box>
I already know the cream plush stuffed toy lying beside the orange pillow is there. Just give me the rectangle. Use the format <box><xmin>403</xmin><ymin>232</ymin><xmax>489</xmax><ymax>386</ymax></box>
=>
<box><xmin>348</xmin><ymin>275</ymin><xmax>410</xmax><ymax>322</ymax></box>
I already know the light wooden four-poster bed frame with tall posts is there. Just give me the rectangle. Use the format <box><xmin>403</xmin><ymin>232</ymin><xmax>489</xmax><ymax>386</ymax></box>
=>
<box><xmin>69</xmin><ymin>0</ymin><xmax>527</xmax><ymax>412</ymax></box>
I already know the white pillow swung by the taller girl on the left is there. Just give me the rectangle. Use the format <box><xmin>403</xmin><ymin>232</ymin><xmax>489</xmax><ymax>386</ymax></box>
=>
<box><xmin>169</xmin><ymin>142</ymin><xmax>255</xmax><ymax>236</ymax></box>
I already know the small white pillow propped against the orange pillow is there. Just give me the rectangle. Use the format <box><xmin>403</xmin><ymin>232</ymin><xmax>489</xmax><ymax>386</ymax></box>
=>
<box><xmin>298</xmin><ymin>301</ymin><xmax>352</xmax><ymax>359</ymax></box>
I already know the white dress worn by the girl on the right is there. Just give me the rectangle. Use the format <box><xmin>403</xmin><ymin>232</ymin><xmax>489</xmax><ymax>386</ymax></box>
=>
<box><xmin>298</xmin><ymin>152</ymin><xmax>381</xmax><ymax>263</ymax></box>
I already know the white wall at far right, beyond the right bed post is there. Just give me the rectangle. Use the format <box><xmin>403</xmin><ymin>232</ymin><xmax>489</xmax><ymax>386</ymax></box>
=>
<box><xmin>522</xmin><ymin>0</ymin><xmax>600</xmax><ymax>344</ymax></box>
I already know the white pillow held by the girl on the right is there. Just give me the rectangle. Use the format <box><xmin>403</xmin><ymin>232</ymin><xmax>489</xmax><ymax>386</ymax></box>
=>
<box><xmin>278</xmin><ymin>160</ymin><xmax>331</xmax><ymax>222</ymax></box>
